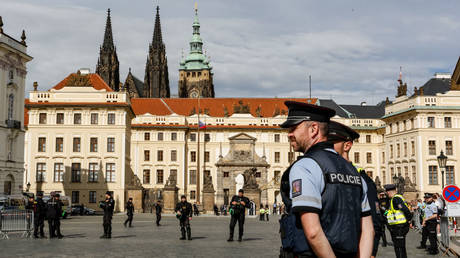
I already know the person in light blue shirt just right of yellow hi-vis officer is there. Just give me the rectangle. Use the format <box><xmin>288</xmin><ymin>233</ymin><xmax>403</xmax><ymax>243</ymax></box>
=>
<box><xmin>417</xmin><ymin>193</ymin><xmax>439</xmax><ymax>255</ymax></box>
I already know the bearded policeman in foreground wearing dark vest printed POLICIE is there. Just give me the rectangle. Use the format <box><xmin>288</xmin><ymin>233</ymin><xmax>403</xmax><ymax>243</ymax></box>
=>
<box><xmin>280</xmin><ymin>101</ymin><xmax>374</xmax><ymax>257</ymax></box>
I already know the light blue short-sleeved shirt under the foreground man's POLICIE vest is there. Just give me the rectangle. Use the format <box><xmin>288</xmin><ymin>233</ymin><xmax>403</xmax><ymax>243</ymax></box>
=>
<box><xmin>289</xmin><ymin>149</ymin><xmax>371</xmax><ymax>213</ymax></box>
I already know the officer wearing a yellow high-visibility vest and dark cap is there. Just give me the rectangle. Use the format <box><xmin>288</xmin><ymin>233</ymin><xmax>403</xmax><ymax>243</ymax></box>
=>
<box><xmin>384</xmin><ymin>184</ymin><xmax>412</xmax><ymax>258</ymax></box>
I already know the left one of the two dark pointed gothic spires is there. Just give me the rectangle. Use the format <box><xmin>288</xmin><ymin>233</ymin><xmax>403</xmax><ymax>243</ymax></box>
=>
<box><xmin>96</xmin><ymin>9</ymin><xmax>120</xmax><ymax>91</ymax></box>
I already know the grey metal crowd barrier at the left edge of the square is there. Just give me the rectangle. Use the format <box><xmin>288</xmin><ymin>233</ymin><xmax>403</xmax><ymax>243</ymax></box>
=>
<box><xmin>0</xmin><ymin>210</ymin><xmax>34</xmax><ymax>239</ymax></box>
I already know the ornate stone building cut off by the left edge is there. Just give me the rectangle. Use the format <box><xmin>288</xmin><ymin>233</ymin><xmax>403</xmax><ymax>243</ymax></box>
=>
<box><xmin>0</xmin><ymin>16</ymin><xmax>32</xmax><ymax>194</ymax></box>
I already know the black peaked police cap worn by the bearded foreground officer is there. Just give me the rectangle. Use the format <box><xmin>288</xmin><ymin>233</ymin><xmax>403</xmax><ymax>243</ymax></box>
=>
<box><xmin>281</xmin><ymin>101</ymin><xmax>335</xmax><ymax>128</ymax></box>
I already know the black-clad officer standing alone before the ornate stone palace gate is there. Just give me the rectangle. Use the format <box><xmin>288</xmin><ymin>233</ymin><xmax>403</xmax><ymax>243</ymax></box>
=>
<box><xmin>227</xmin><ymin>189</ymin><xmax>249</xmax><ymax>242</ymax></box>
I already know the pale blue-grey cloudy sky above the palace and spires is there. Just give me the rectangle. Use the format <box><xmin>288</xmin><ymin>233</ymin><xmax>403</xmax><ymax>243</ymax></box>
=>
<box><xmin>0</xmin><ymin>0</ymin><xmax>460</xmax><ymax>104</ymax></box>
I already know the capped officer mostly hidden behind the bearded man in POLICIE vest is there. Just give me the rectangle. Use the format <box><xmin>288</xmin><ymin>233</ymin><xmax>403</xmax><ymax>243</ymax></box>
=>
<box><xmin>328</xmin><ymin>121</ymin><xmax>384</xmax><ymax>257</ymax></box>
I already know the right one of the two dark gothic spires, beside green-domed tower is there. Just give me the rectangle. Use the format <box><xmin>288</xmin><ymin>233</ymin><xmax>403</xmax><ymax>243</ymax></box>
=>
<box><xmin>142</xmin><ymin>6</ymin><xmax>170</xmax><ymax>98</ymax></box>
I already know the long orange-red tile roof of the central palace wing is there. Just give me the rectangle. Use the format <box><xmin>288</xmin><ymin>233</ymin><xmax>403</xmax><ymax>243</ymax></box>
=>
<box><xmin>131</xmin><ymin>98</ymin><xmax>317</xmax><ymax>117</ymax></box>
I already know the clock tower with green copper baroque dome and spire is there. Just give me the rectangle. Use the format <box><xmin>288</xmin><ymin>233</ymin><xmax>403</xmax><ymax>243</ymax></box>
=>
<box><xmin>179</xmin><ymin>6</ymin><xmax>214</xmax><ymax>98</ymax></box>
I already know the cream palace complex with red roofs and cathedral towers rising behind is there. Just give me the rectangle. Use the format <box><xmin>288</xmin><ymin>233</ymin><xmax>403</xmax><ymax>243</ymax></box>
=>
<box><xmin>20</xmin><ymin>4</ymin><xmax>460</xmax><ymax>211</ymax></box>
